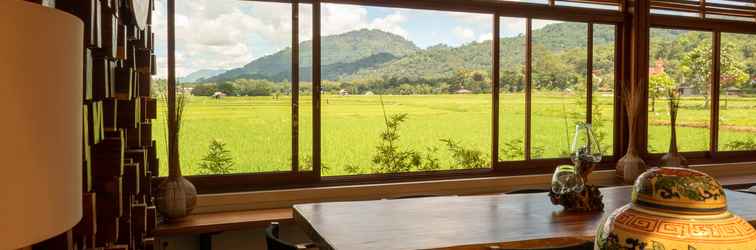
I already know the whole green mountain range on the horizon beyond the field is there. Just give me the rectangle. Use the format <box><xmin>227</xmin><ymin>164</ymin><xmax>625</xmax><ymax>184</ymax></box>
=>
<box><xmin>187</xmin><ymin>22</ymin><xmax>660</xmax><ymax>83</ymax></box>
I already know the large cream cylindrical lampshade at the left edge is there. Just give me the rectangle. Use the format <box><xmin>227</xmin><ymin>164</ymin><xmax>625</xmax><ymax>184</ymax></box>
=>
<box><xmin>0</xmin><ymin>0</ymin><xmax>84</xmax><ymax>250</ymax></box>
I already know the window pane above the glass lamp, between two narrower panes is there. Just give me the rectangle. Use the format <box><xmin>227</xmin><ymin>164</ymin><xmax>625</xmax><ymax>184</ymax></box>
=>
<box><xmin>531</xmin><ymin>20</ymin><xmax>588</xmax><ymax>159</ymax></box>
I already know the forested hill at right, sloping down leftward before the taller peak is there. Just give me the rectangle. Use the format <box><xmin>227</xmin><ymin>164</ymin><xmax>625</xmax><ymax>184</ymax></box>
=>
<box><xmin>346</xmin><ymin>23</ymin><xmax>614</xmax><ymax>81</ymax></box>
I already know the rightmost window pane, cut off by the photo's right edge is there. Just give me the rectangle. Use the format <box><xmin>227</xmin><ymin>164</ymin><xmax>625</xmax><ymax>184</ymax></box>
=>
<box><xmin>718</xmin><ymin>33</ymin><xmax>756</xmax><ymax>151</ymax></box>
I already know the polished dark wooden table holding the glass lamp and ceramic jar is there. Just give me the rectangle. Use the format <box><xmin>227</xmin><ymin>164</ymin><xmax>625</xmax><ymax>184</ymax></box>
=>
<box><xmin>294</xmin><ymin>186</ymin><xmax>756</xmax><ymax>249</ymax></box>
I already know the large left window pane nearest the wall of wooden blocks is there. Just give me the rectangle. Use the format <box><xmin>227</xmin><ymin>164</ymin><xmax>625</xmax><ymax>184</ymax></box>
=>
<box><xmin>161</xmin><ymin>0</ymin><xmax>292</xmax><ymax>175</ymax></box>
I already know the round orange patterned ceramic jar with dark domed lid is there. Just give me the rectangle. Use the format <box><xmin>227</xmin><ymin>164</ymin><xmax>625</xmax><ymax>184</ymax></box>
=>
<box><xmin>595</xmin><ymin>168</ymin><xmax>756</xmax><ymax>250</ymax></box>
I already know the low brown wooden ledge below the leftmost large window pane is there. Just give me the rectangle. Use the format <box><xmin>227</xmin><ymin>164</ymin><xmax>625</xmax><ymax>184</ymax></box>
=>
<box><xmin>155</xmin><ymin>208</ymin><xmax>294</xmax><ymax>236</ymax></box>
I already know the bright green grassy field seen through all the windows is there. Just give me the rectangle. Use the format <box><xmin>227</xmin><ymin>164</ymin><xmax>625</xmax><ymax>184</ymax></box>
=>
<box><xmin>153</xmin><ymin>92</ymin><xmax>756</xmax><ymax>175</ymax></box>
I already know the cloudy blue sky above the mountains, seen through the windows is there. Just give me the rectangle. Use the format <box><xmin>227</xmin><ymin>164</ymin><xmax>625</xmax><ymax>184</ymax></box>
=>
<box><xmin>154</xmin><ymin>0</ymin><xmax>551</xmax><ymax>78</ymax></box>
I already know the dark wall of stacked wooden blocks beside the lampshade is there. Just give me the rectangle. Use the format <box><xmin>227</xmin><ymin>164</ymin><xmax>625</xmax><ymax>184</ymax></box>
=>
<box><xmin>29</xmin><ymin>0</ymin><xmax>159</xmax><ymax>250</ymax></box>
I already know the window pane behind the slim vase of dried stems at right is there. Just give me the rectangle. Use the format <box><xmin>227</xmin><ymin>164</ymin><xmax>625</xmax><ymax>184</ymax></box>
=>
<box><xmin>648</xmin><ymin>29</ymin><xmax>712</xmax><ymax>153</ymax></box>
